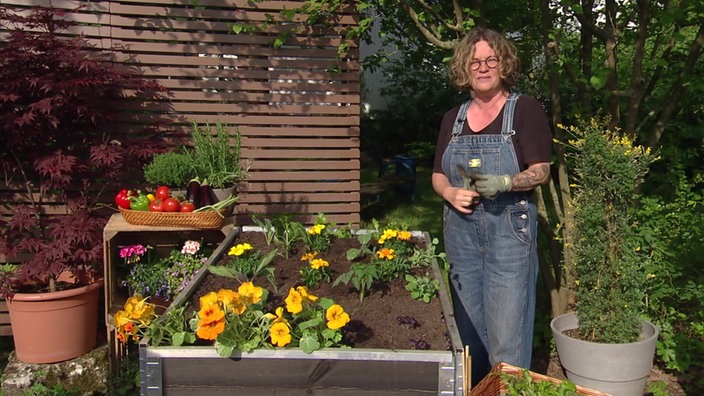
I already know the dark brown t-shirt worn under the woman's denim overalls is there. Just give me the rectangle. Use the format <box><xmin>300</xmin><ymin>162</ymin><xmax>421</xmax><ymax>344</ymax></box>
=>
<box><xmin>433</xmin><ymin>95</ymin><xmax>552</xmax><ymax>173</ymax></box>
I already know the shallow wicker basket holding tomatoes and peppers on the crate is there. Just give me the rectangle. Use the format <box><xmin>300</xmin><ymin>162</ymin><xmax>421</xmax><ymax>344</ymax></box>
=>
<box><xmin>120</xmin><ymin>208</ymin><xmax>225</xmax><ymax>229</ymax></box>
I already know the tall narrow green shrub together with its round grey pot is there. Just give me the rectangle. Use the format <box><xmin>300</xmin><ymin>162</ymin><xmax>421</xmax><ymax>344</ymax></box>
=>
<box><xmin>550</xmin><ymin>118</ymin><xmax>658</xmax><ymax>396</ymax></box>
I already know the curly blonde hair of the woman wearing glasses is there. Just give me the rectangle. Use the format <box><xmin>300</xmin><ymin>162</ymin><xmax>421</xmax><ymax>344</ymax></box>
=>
<box><xmin>449</xmin><ymin>27</ymin><xmax>520</xmax><ymax>91</ymax></box>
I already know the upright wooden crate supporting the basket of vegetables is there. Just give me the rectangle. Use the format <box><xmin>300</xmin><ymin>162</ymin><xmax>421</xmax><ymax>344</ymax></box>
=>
<box><xmin>103</xmin><ymin>213</ymin><xmax>235</xmax><ymax>369</ymax></box>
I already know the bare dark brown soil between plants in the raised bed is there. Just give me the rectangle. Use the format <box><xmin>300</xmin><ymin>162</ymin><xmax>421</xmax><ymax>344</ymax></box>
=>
<box><xmin>189</xmin><ymin>232</ymin><xmax>450</xmax><ymax>350</ymax></box>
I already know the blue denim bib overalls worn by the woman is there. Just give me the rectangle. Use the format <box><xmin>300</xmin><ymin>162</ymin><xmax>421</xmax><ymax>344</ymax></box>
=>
<box><xmin>442</xmin><ymin>94</ymin><xmax>538</xmax><ymax>385</ymax></box>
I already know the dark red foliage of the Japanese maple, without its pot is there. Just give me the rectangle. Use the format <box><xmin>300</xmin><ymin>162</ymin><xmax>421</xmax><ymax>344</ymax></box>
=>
<box><xmin>0</xmin><ymin>6</ymin><xmax>173</xmax><ymax>296</ymax></box>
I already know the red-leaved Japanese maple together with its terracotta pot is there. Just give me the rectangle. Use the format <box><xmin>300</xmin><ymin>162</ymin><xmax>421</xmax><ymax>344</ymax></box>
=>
<box><xmin>0</xmin><ymin>7</ymin><xmax>168</xmax><ymax>363</ymax></box>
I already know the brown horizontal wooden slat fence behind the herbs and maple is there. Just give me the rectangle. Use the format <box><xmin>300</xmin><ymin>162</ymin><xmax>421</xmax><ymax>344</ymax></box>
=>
<box><xmin>0</xmin><ymin>0</ymin><xmax>360</xmax><ymax>224</ymax></box>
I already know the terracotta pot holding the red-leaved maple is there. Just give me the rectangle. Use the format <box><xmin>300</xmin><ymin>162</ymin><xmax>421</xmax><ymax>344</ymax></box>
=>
<box><xmin>7</xmin><ymin>279</ymin><xmax>103</xmax><ymax>363</ymax></box>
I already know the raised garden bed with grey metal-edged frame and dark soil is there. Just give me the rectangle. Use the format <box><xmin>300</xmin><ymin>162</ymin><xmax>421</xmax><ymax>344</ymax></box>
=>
<box><xmin>139</xmin><ymin>227</ymin><xmax>464</xmax><ymax>395</ymax></box>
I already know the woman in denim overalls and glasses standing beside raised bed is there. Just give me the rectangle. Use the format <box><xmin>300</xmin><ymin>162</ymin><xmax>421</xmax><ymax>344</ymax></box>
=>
<box><xmin>432</xmin><ymin>28</ymin><xmax>552</xmax><ymax>385</ymax></box>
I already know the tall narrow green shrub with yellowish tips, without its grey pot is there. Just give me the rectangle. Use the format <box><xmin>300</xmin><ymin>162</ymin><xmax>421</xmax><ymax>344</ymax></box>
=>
<box><xmin>567</xmin><ymin>118</ymin><xmax>657</xmax><ymax>343</ymax></box>
